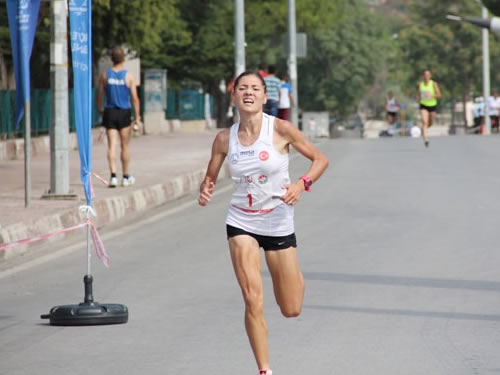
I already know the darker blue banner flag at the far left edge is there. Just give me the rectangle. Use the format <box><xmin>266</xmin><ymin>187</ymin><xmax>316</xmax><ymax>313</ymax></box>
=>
<box><xmin>7</xmin><ymin>0</ymin><xmax>40</xmax><ymax>129</ymax></box>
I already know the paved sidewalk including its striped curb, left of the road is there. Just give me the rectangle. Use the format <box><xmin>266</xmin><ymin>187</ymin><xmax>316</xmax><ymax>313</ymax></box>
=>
<box><xmin>0</xmin><ymin>129</ymin><xmax>227</xmax><ymax>262</ymax></box>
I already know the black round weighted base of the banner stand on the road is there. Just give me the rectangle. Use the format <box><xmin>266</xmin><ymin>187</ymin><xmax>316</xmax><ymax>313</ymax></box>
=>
<box><xmin>40</xmin><ymin>275</ymin><xmax>128</xmax><ymax>326</ymax></box>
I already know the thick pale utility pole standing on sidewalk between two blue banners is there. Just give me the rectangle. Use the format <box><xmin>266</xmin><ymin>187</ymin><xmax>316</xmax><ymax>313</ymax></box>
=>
<box><xmin>43</xmin><ymin>0</ymin><xmax>76</xmax><ymax>199</ymax></box>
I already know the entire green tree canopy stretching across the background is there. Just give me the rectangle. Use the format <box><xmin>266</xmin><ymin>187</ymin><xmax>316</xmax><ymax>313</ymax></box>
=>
<box><xmin>7</xmin><ymin>0</ymin><xmax>490</xmax><ymax>119</ymax></box>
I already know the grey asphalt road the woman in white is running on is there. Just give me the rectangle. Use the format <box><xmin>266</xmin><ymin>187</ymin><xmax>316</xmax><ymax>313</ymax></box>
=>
<box><xmin>0</xmin><ymin>136</ymin><xmax>500</xmax><ymax>375</ymax></box>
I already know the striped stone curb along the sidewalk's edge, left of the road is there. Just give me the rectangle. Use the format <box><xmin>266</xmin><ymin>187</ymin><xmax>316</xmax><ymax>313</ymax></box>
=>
<box><xmin>0</xmin><ymin>164</ymin><xmax>229</xmax><ymax>261</ymax></box>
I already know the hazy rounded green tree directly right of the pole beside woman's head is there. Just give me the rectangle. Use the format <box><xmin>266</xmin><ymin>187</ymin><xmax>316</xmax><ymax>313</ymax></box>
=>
<box><xmin>299</xmin><ymin>0</ymin><xmax>387</xmax><ymax>115</ymax></box>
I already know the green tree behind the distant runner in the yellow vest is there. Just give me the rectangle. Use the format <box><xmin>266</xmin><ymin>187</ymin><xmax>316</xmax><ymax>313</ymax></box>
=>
<box><xmin>400</xmin><ymin>0</ymin><xmax>500</xmax><ymax>117</ymax></box>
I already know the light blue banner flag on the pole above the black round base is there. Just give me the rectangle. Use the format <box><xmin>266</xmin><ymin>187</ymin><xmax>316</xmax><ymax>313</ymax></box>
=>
<box><xmin>69</xmin><ymin>0</ymin><xmax>92</xmax><ymax>206</ymax></box>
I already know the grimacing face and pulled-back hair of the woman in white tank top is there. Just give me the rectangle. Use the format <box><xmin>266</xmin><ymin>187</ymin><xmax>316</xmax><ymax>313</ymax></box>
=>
<box><xmin>233</xmin><ymin>75</ymin><xmax>267</xmax><ymax>113</ymax></box>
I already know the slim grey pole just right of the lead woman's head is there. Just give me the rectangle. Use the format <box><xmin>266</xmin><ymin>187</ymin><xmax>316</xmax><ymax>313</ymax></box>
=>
<box><xmin>288</xmin><ymin>0</ymin><xmax>299</xmax><ymax>127</ymax></box>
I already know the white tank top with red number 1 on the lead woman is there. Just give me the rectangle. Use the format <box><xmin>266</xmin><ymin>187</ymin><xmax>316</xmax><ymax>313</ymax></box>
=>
<box><xmin>226</xmin><ymin>114</ymin><xmax>294</xmax><ymax>236</ymax></box>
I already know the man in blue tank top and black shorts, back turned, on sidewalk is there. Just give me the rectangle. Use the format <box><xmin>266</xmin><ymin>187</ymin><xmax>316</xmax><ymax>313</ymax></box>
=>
<box><xmin>97</xmin><ymin>47</ymin><xmax>140</xmax><ymax>188</ymax></box>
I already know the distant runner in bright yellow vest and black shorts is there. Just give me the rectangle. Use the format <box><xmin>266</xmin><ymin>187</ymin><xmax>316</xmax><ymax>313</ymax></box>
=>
<box><xmin>417</xmin><ymin>70</ymin><xmax>441</xmax><ymax>147</ymax></box>
